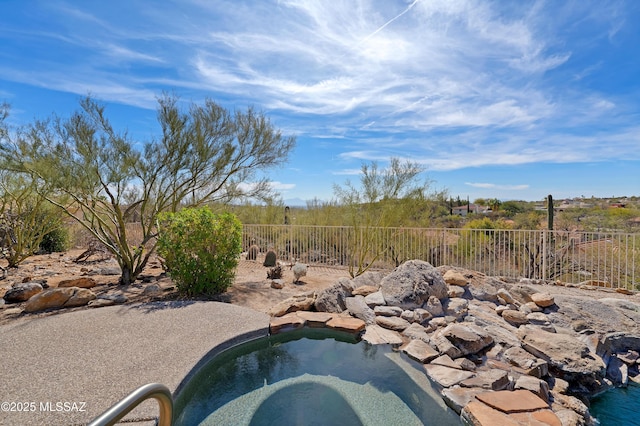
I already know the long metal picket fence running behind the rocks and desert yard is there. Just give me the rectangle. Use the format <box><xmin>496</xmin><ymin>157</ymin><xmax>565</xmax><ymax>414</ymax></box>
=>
<box><xmin>243</xmin><ymin>225</ymin><xmax>640</xmax><ymax>290</ymax></box>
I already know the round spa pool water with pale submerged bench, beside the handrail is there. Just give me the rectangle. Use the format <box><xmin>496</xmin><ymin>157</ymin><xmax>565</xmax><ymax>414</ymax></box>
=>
<box><xmin>174</xmin><ymin>329</ymin><xmax>460</xmax><ymax>426</ymax></box>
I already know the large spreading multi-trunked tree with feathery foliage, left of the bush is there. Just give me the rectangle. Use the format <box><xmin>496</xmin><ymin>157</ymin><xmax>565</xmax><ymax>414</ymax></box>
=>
<box><xmin>0</xmin><ymin>95</ymin><xmax>295</xmax><ymax>284</ymax></box>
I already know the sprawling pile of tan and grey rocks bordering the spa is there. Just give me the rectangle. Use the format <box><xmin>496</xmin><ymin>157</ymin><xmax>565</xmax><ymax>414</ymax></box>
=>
<box><xmin>270</xmin><ymin>260</ymin><xmax>640</xmax><ymax>426</ymax></box>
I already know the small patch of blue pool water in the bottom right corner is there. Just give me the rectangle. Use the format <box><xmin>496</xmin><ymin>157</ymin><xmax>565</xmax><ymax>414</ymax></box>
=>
<box><xmin>589</xmin><ymin>385</ymin><xmax>640</xmax><ymax>426</ymax></box>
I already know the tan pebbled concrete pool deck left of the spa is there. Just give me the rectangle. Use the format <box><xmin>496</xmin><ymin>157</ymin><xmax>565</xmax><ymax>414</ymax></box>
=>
<box><xmin>0</xmin><ymin>301</ymin><xmax>269</xmax><ymax>425</ymax></box>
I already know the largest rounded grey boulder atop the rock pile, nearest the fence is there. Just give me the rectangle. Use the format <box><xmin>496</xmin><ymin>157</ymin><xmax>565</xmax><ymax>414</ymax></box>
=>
<box><xmin>380</xmin><ymin>260</ymin><xmax>447</xmax><ymax>309</ymax></box>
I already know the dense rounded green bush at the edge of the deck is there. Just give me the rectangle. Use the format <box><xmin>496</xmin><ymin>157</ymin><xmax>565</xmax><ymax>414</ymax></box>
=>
<box><xmin>158</xmin><ymin>207</ymin><xmax>242</xmax><ymax>296</ymax></box>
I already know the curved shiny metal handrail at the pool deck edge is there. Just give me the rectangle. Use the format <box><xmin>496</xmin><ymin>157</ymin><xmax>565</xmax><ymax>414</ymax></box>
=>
<box><xmin>89</xmin><ymin>383</ymin><xmax>173</xmax><ymax>426</ymax></box>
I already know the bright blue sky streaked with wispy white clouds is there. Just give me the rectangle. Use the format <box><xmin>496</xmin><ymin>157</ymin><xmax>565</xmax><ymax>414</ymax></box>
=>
<box><xmin>0</xmin><ymin>0</ymin><xmax>640</xmax><ymax>206</ymax></box>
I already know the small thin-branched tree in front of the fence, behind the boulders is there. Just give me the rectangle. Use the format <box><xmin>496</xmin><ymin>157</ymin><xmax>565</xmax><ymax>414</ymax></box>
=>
<box><xmin>334</xmin><ymin>157</ymin><xmax>429</xmax><ymax>277</ymax></box>
